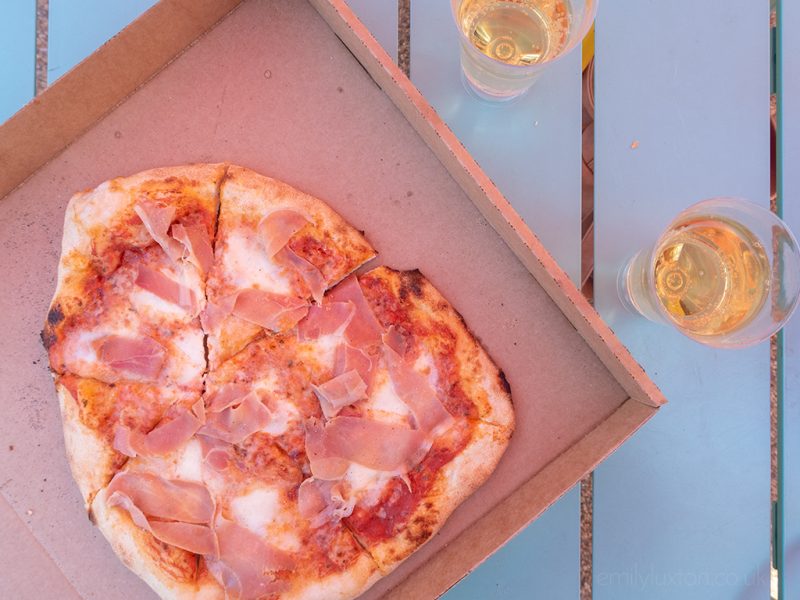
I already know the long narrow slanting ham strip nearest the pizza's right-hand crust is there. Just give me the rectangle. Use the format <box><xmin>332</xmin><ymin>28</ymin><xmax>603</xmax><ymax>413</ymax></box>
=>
<box><xmin>383</xmin><ymin>346</ymin><xmax>454</xmax><ymax>437</ymax></box>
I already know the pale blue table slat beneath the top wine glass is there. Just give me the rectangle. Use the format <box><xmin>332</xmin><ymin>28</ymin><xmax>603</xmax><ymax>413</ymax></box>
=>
<box><xmin>411</xmin><ymin>0</ymin><xmax>581</xmax><ymax>599</ymax></box>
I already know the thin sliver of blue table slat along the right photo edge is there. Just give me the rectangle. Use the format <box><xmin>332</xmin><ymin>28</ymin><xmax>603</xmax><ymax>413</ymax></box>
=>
<box><xmin>778</xmin><ymin>0</ymin><xmax>800</xmax><ymax>599</ymax></box>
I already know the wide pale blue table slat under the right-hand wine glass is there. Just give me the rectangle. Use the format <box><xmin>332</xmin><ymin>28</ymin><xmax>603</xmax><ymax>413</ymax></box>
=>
<box><xmin>593</xmin><ymin>0</ymin><xmax>770</xmax><ymax>600</ymax></box>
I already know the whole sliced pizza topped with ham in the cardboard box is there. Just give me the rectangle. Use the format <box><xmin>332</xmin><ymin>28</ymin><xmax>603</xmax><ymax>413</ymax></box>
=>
<box><xmin>42</xmin><ymin>164</ymin><xmax>514</xmax><ymax>599</ymax></box>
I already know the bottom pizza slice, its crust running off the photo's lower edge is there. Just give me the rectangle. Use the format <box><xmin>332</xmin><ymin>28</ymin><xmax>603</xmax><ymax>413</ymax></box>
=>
<box><xmin>92</xmin><ymin>422</ymin><xmax>380</xmax><ymax>600</ymax></box>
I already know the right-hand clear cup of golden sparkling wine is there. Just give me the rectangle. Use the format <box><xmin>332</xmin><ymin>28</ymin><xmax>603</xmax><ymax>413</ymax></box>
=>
<box><xmin>618</xmin><ymin>198</ymin><xmax>800</xmax><ymax>347</ymax></box>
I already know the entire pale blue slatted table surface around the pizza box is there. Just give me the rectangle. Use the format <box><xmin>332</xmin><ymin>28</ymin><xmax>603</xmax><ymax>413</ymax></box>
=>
<box><xmin>0</xmin><ymin>0</ymin><xmax>800</xmax><ymax>600</ymax></box>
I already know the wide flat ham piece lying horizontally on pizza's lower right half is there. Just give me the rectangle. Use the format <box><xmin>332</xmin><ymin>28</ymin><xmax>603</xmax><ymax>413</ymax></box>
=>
<box><xmin>306</xmin><ymin>417</ymin><xmax>430</xmax><ymax>479</ymax></box>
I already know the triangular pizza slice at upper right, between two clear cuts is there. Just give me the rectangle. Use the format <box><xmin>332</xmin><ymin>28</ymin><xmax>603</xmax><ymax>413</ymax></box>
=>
<box><xmin>203</xmin><ymin>166</ymin><xmax>375</xmax><ymax>369</ymax></box>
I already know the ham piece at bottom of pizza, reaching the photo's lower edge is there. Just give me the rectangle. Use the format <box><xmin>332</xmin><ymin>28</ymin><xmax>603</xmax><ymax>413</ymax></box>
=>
<box><xmin>205</xmin><ymin>517</ymin><xmax>295</xmax><ymax>600</ymax></box>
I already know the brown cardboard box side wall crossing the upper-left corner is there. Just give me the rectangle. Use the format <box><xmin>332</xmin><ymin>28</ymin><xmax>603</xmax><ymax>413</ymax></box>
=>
<box><xmin>0</xmin><ymin>0</ymin><xmax>242</xmax><ymax>199</ymax></box>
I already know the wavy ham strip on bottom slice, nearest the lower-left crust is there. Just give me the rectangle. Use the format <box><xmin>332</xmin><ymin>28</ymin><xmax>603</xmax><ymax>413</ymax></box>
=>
<box><xmin>108</xmin><ymin>471</ymin><xmax>214</xmax><ymax>524</ymax></box>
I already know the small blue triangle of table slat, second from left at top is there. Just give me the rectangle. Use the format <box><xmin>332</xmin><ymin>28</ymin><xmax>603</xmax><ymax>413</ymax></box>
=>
<box><xmin>47</xmin><ymin>0</ymin><xmax>157</xmax><ymax>84</ymax></box>
